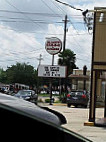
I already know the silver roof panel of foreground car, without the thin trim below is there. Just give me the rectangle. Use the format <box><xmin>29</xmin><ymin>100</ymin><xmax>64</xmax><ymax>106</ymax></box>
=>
<box><xmin>0</xmin><ymin>93</ymin><xmax>60</xmax><ymax>125</ymax></box>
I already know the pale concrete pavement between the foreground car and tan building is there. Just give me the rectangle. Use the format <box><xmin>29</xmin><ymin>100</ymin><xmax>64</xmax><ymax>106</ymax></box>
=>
<box><xmin>39</xmin><ymin>104</ymin><xmax>106</xmax><ymax>142</ymax></box>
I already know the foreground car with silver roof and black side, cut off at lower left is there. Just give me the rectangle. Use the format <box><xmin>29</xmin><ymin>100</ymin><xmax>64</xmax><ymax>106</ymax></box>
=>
<box><xmin>0</xmin><ymin>93</ymin><xmax>91</xmax><ymax>142</ymax></box>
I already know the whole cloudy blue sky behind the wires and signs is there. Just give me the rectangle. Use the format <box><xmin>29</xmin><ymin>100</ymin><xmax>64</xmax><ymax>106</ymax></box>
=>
<box><xmin>0</xmin><ymin>0</ymin><xmax>106</xmax><ymax>69</ymax></box>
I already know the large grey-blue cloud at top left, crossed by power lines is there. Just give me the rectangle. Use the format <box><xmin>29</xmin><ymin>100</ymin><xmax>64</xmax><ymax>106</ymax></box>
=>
<box><xmin>1</xmin><ymin>0</ymin><xmax>63</xmax><ymax>32</ymax></box>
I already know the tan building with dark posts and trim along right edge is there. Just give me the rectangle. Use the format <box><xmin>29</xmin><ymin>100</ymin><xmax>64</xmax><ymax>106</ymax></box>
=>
<box><xmin>89</xmin><ymin>7</ymin><xmax>106</xmax><ymax>126</ymax></box>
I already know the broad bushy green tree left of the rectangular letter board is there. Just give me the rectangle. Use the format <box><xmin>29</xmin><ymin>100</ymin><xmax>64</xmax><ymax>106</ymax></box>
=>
<box><xmin>6</xmin><ymin>63</ymin><xmax>37</xmax><ymax>86</ymax></box>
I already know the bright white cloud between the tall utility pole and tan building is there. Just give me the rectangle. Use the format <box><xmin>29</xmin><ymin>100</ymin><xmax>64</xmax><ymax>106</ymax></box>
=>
<box><xmin>67</xmin><ymin>26</ymin><xmax>92</xmax><ymax>69</ymax></box>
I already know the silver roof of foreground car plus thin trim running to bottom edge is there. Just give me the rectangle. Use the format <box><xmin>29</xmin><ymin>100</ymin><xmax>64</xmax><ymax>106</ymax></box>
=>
<box><xmin>0</xmin><ymin>93</ymin><xmax>90</xmax><ymax>142</ymax></box>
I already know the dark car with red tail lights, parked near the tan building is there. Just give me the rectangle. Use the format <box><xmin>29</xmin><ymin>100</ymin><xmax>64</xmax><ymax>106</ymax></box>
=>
<box><xmin>67</xmin><ymin>91</ymin><xmax>89</xmax><ymax>108</ymax></box>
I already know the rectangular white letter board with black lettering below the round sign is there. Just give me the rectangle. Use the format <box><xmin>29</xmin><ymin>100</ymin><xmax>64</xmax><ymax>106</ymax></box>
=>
<box><xmin>38</xmin><ymin>65</ymin><xmax>66</xmax><ymax>78</ymax></box>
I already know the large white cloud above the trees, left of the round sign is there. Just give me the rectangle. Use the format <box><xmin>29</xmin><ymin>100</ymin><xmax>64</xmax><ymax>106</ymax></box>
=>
<box><xmin>0</xmin><ymin>26</ymin><xmax>42</xmax><ymax>68</ymax></box>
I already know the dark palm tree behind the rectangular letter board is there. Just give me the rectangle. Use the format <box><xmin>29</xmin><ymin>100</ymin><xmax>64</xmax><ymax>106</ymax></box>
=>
<box><xmin>58</xmin><ymin>49</ymin><xmax>78</xmax><ymax>75</ymax></box>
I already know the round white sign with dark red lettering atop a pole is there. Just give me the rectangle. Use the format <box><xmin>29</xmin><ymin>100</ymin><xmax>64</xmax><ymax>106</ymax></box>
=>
<box><xmin>45</xmin><ymin>37</ymin><xmax>62</xmax><ymax>55</ymax></box>
